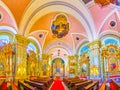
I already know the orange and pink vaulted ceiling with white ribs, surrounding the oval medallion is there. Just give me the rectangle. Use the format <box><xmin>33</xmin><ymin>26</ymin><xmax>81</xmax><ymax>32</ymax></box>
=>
<box><xmin>0</xmin><ymin>0</ymin><xmax>120</xmax><ymax>60</ymax></box>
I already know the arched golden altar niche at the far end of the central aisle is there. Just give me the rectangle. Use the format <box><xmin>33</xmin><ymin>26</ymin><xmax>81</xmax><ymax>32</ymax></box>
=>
<box><xmin>51</xmin><ymin>58</ymin><xmax>65</xmax><ymax>77</ymax></box>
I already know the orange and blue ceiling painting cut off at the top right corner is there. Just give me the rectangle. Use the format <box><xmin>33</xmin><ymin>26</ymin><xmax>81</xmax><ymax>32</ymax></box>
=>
<box><xmin>94</xmin><ymin>0</ymin><xmax>119</xmax><ymax>6</ymax></box>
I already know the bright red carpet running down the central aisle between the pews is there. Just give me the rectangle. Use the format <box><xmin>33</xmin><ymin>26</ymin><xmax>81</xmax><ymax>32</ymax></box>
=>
<box><xmin>51</xmin><ymin>80</ymin><xmax>65</xmax><ymax>90</ymax></box>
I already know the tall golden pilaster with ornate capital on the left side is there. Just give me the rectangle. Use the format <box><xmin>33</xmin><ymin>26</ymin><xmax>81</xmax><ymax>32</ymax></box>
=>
<box><xmin>15</xmin><ymin>34</ymin><xmax>30</xmax><ymax>79</ymax></box>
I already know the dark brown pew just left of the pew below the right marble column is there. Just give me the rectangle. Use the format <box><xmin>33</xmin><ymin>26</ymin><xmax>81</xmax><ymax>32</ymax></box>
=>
<box><xmin>72</xmin><ymin>80</ymin><xmax>93</xmax><ymax>90</ymax></box>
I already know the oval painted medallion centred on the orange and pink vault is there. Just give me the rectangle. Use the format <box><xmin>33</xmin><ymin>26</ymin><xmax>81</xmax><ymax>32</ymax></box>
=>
<box><xmin>51</xmin><ymin>14</ymin><xmax>69</xmax><ymax>38</ymax></box>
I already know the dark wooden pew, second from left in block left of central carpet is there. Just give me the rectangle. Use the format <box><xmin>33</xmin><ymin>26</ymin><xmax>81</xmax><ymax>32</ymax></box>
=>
<box><xmin>24</xmin><ymin>80</ymin><xmax>47</xmax><ymax>90</ymax></box>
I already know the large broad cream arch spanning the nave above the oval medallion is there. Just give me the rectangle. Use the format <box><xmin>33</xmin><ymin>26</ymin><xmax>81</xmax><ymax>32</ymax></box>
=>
<box><xmin>20</xmin><ymin>0</ymin><xmax>96</xmax><ymax>40</ymax></box>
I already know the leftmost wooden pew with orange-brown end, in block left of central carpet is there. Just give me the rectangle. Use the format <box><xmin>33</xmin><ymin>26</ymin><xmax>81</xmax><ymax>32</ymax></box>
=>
<box><xmin>18</xmin><ymin>81</ymin><xmax>38</xmax><ymax>90</ymax></box>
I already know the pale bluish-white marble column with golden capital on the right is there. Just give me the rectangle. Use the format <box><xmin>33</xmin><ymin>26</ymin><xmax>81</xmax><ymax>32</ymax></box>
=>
<box><xmin>88</xmin><ymin>40</ymin><xmax>101</xmax><ymax>78</ymax></box>
